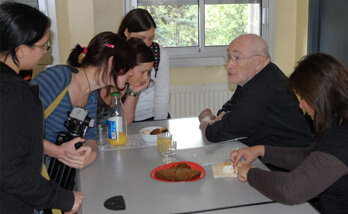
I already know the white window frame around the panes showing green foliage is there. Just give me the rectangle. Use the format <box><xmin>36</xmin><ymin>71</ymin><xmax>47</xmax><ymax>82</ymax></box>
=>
<box><xmin>123</xmin><ymin>0</ymin><xmax>275</xmax><ymax>67</ymax></box>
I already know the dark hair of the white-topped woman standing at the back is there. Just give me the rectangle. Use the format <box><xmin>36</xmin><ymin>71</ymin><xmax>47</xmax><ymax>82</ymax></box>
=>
<box><xmin>117</xmin><ymin>8</ymin><xmax>157</xmax><ymax>39</ymax></box>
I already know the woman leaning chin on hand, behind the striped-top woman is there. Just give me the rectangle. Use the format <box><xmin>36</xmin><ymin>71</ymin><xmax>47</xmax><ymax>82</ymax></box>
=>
<box><xmin>97</xmin><ymin>38</ymin><xmax>154</xmax><ymax>124</ymax></box>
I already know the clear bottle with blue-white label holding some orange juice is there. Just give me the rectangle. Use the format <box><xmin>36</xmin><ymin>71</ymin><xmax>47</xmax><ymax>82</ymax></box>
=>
<box><xmin>108</xmin><ymin>92</ymin><xmax>127</xmax><ymax>146</ymax></box>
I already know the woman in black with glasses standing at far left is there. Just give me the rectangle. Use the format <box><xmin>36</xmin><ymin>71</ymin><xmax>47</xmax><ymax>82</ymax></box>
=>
<box><xmin>0</xmin><ymin>3</ymin><xmax>83</xmax><ymax>213</ymax></box>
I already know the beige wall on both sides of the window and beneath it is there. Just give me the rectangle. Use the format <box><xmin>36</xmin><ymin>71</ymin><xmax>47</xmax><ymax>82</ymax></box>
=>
<box><xmin>56</xmin><ymin>0</ymin><xmax>308</xmax><ymax>85</ymax></box>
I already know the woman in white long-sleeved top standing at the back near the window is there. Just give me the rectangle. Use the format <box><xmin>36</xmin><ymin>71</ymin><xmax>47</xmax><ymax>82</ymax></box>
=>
<box><xmin>118</xmin><ymin>8</ymin><xmax>170</xmax><ymax>121</ymax></box>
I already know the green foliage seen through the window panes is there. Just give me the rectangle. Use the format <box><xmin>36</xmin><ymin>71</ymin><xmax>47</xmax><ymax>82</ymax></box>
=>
<box><xmin>141</xmin><ymin>4</ymin><xmax>248</xmax><ymax>47</ymax></box>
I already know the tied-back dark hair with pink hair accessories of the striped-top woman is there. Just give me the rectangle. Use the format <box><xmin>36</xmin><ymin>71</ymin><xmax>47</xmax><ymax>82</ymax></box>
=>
<box><xmin>67</xmin><ymin>32</ymin><xmax>135</xmax><ymax>89</ymax></box>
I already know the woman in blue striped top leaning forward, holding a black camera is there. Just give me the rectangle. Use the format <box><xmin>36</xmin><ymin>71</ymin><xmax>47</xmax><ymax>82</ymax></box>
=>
<box><xmin>31</xmin><ymin>32</ymin><xmax>135</xmax><ymax>169</ymax></box>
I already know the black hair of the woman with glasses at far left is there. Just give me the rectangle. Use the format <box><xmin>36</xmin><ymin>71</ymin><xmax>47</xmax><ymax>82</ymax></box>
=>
<box><xmin>0</xmin><ymin>2</ymin><xmax>51</xmax><ymax>66</ymax></box>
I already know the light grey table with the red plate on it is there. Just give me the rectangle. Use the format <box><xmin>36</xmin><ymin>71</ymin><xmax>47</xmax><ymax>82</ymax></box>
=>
<box><xmin>77</xmin><ymin>118</ymin><xmax>317</xmax><ymax>214</ymax></box>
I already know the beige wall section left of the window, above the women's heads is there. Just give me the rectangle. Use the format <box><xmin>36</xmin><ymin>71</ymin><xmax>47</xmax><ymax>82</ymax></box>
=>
<box><xmin>56</xmin><ymin>0</ymin><xmax>123</xmax><ymax>64</ymax></box>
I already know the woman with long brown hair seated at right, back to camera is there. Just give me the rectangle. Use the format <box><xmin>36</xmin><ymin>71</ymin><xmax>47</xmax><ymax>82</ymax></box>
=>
<box><xmin>231</xmin><ymin>53</ymin><xmax>348</xmax><ymax>213</ymax></box>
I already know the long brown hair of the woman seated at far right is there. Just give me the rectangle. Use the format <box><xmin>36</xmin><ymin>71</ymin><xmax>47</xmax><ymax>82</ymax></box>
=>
<box><xmin>288</xmin><ymin>53</ymin><xmax>348</xmax><ymax>137</ymax></box>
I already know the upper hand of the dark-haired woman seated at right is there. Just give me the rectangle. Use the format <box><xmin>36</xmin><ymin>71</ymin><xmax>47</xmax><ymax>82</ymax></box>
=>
<box><xmin>231</xmin><ymin>145</ymin><xmax>265</xmax><ymax>166</ymax></box>
